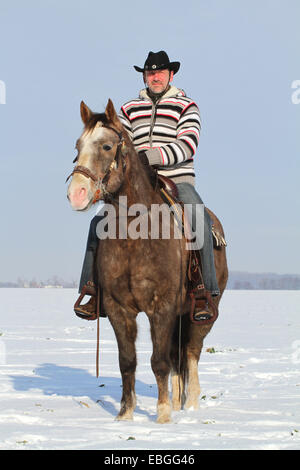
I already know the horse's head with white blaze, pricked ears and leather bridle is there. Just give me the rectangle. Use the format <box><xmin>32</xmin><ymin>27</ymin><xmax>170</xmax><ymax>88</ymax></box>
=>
<box><xmin>67</xmin><ymin>99</ymin><xmax>128</xmax><ymax>211</ymax></box>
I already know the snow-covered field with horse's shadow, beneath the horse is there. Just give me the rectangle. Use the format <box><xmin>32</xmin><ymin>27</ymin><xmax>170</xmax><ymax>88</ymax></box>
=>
<box><xmin>0</xmin><ymin>289</ymin><xmax>300</xmax><ymax>452</ymax></box>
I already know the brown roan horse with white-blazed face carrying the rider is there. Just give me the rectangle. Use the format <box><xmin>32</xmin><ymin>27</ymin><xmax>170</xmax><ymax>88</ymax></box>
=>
<box><xmin>68</xmin><ymin>100</ymin><xmax>228</xmax><ymax>423</ymax></box>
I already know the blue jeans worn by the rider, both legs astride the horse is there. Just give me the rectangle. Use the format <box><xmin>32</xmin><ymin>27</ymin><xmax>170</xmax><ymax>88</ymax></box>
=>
<box><xmin>79</xmin><ymin>183</ymin><xmax>220</xmax><ymax>296</ymax></box>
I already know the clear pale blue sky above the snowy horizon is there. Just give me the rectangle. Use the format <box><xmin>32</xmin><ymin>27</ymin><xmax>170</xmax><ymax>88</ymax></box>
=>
<box><xmin>0</xmin><ymin>0</ymin><xmax>300</xmax><ymax>281</ymax></box>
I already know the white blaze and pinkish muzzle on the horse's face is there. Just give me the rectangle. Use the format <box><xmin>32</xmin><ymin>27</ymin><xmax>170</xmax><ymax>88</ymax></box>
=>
<box><xmin>68</xmin><ymin>122</ymin><xmax>105</xmax><ymax>211</ymax></box>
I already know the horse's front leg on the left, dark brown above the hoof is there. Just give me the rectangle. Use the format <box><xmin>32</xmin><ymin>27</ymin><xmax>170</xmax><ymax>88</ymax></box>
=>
<box><xmin>109</xmin><ymin>310</ymin><xmax>137</xmax><ymax>420</ymax></box>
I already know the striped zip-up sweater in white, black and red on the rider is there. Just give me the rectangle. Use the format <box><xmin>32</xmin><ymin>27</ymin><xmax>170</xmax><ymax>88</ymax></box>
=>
<box><xmin>119</xmin><ymin>86</ymin><xmax>201</xmax><ymax>185</ymax></box>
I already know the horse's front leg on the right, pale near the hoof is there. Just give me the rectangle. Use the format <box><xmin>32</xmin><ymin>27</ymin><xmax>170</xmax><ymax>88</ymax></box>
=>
<box><xmin>149</xmin><ymin>312</ymin><xmax>175</xmax><ymax>423</ymax></box>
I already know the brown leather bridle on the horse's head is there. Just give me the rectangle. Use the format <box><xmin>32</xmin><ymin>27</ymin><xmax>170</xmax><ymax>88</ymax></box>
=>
<box><xmin>66</xmin><ymin>126</ymin><xmax>126</xmax><ymax>204</ymax></box>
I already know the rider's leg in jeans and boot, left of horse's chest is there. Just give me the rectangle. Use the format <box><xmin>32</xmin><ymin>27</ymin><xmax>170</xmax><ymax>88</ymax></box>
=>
<box><xmin>74</xmin><ymin>216</ymin><xmax>107</xmax><ymax>320</ymax></box>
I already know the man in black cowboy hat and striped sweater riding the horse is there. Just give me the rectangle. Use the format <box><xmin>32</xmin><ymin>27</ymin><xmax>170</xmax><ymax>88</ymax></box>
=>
<box><xmin>75</xmin><ymin>51</ymin><xmax>219</xmax><ymax>321</ymax></box>
